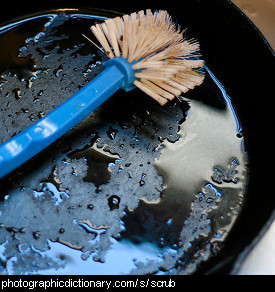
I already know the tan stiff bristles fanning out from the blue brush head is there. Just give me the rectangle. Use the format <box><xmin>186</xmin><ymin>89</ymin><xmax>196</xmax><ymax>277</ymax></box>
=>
<box><xmin>91</xmin><ymin>9</ymin><xmax>204</xmax><ymax>105</ymax></box>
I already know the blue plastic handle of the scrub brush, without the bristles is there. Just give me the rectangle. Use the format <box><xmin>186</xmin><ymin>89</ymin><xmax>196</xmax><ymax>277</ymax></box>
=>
<box><xmin>0</xmin><ymin>57</ymin><xmax>134</xmax><ymax>178</ymax></box>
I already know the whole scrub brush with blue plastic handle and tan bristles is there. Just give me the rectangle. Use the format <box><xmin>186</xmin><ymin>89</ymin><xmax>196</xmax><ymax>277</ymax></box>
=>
<box><xmin>0</xmin><ymin>9</ymin><xmax>204</xmax><ymax>178</ymax></box>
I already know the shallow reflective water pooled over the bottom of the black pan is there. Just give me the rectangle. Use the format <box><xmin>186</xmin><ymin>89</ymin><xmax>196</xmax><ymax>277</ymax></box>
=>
<box><xmin>0</xmin><ymin>11</ymin><xmax>246</xmax><ymax>274</ymax></box>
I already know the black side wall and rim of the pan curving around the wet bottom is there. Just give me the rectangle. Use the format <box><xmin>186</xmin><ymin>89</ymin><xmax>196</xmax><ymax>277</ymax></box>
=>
<box><xmin>0</xmin><ymin>0</ymin><xmax>275</xmax><ymax>274</ymax></box>
